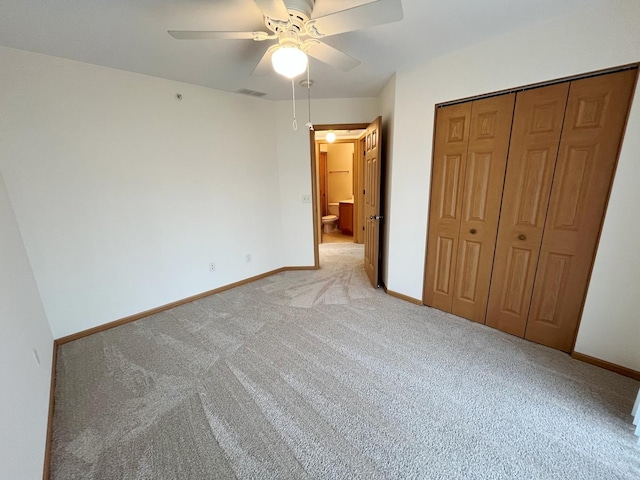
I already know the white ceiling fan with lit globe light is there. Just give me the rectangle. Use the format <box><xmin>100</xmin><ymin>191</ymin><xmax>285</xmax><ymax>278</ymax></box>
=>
<box><xmin>169</xmin><ymin>0</ymin><xmax>403</xmax><ymax>78</ymax></box>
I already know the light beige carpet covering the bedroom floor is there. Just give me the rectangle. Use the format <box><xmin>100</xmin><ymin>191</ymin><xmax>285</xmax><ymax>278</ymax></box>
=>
<box><xmin>52</xmin><ymin>244</ymin><xmax>640</xmax><ymax>480</ymax></box>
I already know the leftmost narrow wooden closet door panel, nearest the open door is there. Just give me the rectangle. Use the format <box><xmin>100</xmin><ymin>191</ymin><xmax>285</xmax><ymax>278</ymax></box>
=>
<box><xmin>422</xmin><ymin>102</ymin><xmax>471</xmax><ymax>312</ymax></box>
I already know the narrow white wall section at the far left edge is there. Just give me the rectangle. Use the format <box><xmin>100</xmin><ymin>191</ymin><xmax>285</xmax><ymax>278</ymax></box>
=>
<box><xmin>0</xmin><ymin>171</ymin><xmax>53</xmax><ymax>479</ymax></box>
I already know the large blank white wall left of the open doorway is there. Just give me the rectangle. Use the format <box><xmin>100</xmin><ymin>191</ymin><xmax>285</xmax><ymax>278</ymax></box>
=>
<box><xmin>0</xmin><ymin>48</ymin><xmax>282</xmax><ymax>338</ymax></box>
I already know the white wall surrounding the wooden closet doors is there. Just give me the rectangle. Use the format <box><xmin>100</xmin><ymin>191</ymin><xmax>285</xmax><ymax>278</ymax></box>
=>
<box><xmin>387</xmin><ymin>0</ymin><xmax>640</xmax><ymax>370</ymax></box>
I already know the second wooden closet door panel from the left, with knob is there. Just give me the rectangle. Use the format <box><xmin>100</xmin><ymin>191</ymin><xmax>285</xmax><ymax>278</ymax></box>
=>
<box><xmin>451</xmin><ymin>94</ymin><xmax>515</xmax><ymax>323</ymax></box>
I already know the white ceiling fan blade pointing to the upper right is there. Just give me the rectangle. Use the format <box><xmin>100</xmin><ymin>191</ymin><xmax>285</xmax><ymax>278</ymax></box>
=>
<box><xmin>306</xmin><ymin>0</ymin><xmax>404</xmax><ymax>38</ymax></box>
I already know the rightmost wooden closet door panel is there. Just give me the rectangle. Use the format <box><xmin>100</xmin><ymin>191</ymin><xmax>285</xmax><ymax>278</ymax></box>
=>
<box><xmin>525</xmin><ymin>70</ymin><xmax>637</xmax><ymax>352</ymax></box>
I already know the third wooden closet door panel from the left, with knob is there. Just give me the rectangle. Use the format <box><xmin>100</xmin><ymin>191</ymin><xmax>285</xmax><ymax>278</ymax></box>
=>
<box><xmin>486</xmin><ymin>83</ymin><xmax>569</xmax><ymax>337</ymax></box>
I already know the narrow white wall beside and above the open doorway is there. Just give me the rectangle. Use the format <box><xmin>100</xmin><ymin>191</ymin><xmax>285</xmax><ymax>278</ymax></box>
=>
<box><xmin>275</xmin><ymin>95</ymin><xmax>379</xmax><ymax>266</ymax></box>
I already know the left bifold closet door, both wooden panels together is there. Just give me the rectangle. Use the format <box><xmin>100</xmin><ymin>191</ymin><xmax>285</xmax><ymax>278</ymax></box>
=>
<box><xmin>423</xmin><ymin>94</ymin><xmax>515</xmax><ymax>323</ymax></box>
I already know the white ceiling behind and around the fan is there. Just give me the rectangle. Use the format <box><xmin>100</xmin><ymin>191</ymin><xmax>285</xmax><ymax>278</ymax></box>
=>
<box><xmin>0</xmin><ymin>0</ymin><xmax>611</xmax><ymax>100</ymax></box>
